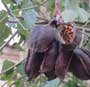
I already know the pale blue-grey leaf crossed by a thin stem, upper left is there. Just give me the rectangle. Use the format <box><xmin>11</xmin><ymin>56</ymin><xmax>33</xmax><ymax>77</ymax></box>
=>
<box><xmin>22</xmin><ymin>0</ymin><xmax>37</xmax><ymax>29</ymax></box>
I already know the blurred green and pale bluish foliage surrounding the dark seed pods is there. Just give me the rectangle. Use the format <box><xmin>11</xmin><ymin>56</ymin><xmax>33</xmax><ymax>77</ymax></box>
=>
<box><xmin>0</xmin><ymin>0</ymin><xmax>90</xmax><ymax>87</ymax></box>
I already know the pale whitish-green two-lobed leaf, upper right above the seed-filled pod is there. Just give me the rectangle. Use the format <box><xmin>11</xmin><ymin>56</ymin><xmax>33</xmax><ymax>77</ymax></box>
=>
<box><xmin>62</xmin><ymin>7</ymin><xmax>90</xmax><ymax>23</ymax></box>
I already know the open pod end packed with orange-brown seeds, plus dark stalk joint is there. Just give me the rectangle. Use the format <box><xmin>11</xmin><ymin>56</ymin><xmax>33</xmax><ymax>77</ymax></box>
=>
<box><xmin>50</xmin><ymin>19</ymin><xmax>76</xmax><ymax>44</ymax></box>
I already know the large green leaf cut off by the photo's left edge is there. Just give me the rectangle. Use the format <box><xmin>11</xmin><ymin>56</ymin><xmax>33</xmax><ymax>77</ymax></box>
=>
<box><xmin>0</xmin><ymin>10</ymin><xmax>10</xmax><ymax>46</ymax></box>
